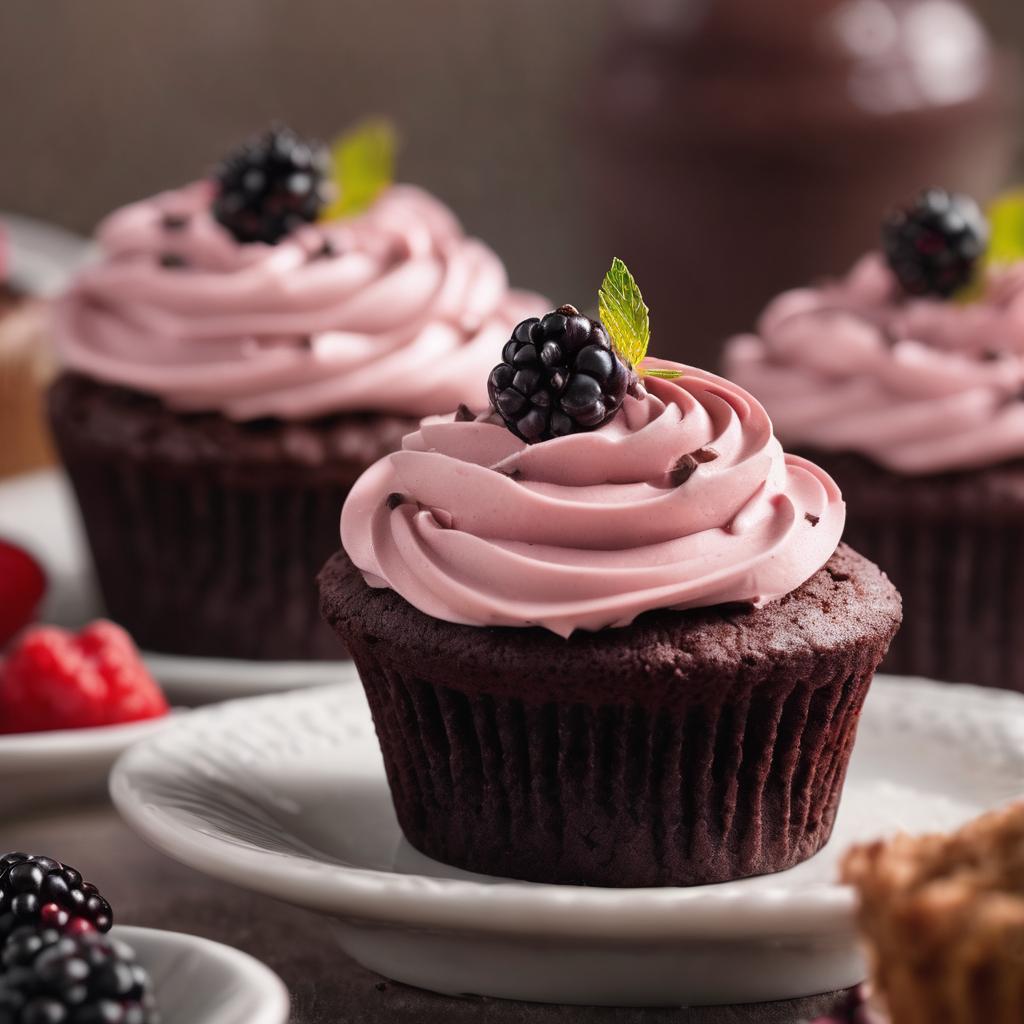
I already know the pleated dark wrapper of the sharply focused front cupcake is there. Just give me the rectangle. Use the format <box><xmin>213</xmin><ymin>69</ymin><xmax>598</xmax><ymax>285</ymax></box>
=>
<box><xmin>349</xmin><ymin>637</ymin><xmax>882</xmax><ymax>887</ymax></box>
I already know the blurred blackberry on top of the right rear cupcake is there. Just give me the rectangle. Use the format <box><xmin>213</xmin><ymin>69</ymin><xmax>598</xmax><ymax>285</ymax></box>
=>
<box><xmin>882</xmin><ymin>188</ymin><xmax>988</xmax><ymax>298</ymax></box>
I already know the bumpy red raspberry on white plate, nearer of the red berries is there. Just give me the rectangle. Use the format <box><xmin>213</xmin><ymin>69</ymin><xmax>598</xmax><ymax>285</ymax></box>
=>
<box><xmin>0</xmin><ymin>621</ymin><xmax>167</xmax><ymax>733</ymax></box>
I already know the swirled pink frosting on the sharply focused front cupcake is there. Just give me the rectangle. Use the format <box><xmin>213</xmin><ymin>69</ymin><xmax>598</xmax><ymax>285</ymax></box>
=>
<box><xmin>341</xmin><ymin>360</ymin><xmax>846</xmax><ymax>636</ymax></box>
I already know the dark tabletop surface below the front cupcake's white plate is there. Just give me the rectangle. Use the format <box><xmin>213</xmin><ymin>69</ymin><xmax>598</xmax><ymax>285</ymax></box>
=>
<box><xmin>8</xmin><ymin>807</ymin><xmax>840</xmax><ymax>1024</ymax></box>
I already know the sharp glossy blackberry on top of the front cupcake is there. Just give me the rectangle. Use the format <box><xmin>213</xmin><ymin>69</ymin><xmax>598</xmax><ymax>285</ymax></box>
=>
<box><xmin>487</xmin><ymin>305</ymin><xmax>634</xmax><ymax>444</ymax></box>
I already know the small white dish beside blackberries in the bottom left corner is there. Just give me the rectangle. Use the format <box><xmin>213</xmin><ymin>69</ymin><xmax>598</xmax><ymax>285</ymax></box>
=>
<box><xmin>112</xmin><ymin>925</ymin><xmax>289</xmax><ymax>1024</ymax></box>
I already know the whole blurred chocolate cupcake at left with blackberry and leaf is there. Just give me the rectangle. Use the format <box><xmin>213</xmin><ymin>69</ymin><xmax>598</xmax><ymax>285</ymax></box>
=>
<box><xmin>49</xmin><ymin>122</ymin><xmax>543</xmax><ymax>659</ymax></box>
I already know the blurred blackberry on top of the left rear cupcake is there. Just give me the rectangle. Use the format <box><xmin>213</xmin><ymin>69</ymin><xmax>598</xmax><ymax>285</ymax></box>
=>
<box><xmin>213</xmin><ymin>122</ymin><xmax>331</xmax><ymax>246</ymax></box>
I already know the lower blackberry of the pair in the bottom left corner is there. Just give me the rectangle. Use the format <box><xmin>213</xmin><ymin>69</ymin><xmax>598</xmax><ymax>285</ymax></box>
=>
<box><xmin>0</xmin><ymin>927</ymin><xmax>160</xmax><ymax>1024</ymax></box>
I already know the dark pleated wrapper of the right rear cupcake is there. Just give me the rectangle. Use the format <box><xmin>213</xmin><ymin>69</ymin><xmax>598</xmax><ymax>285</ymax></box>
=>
<box><xmin>844</xmin><ymin>516</ymin><xmax>1024</xmax><ymax>692</ymax></box>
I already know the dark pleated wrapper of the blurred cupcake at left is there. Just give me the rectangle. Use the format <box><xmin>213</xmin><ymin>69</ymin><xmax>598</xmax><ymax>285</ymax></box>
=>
<box><xmin>61</xmin><ymin>443</ymin><xmax>346</xmax><ymax>659</ymax></box>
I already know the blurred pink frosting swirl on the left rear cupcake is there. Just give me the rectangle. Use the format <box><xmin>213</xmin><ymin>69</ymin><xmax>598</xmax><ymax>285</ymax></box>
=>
<box><xmin>57</xmin><ymin>182</ymin><xmax>546</xmax><ymax>420</ymax></box>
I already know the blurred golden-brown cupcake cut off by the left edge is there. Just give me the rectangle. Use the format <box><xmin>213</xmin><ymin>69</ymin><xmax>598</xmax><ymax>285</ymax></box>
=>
<box><xmin>0</xmin><ymin>223</ymin><xmax>53</xmax><ymax>477</ymax></box>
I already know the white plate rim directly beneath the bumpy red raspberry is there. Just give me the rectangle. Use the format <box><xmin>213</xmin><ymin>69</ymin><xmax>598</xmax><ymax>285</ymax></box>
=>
<box><xmin>0</xmin><ymin>717</ymin><xmax>170</xmax><ymax>820</ymax></box>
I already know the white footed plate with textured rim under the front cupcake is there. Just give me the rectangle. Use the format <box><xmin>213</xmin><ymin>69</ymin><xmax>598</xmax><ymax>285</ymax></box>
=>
<box><xmin>112</xmin><ymin>677</ymin><xmax>1024</xmax><ymax>1006</ymax></box>
